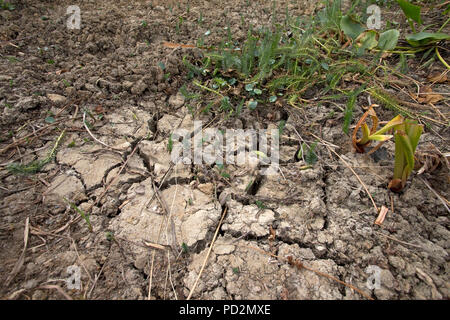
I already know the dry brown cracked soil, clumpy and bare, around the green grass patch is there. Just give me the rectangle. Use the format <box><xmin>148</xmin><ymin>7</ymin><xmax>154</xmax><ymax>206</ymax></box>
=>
<box><xmin>0</xmin><ymin>1</ymin><xmax>450</xmax><ymax>300</ymax></box>
